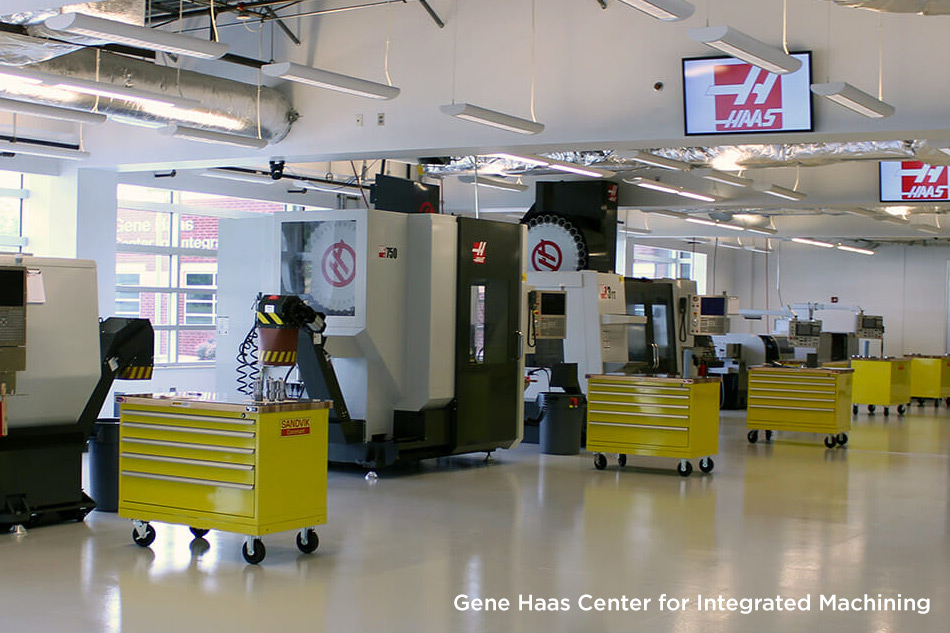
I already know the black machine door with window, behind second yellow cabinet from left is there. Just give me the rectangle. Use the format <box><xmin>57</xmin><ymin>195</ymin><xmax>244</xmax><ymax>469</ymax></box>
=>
<box><xmin>624</xmin><ymin>279</ymin><xmax>686</xmax><ymax>374</ymax></box>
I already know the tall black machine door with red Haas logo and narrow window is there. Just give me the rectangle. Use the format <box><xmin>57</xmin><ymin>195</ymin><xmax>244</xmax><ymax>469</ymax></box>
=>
<box><xmin>452</xmin><ymin>218</ymin><xmax>522</xmax><ymax>453</ymax></box>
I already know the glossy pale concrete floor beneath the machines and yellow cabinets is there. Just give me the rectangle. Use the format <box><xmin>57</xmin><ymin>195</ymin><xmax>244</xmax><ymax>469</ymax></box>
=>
<box><xmin>0</xmin><ymin>405</ymin><xmax>950</xmax><ymax>633</ymax></box>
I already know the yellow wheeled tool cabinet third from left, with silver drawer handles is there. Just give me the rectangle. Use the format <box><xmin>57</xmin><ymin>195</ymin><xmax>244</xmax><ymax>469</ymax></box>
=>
<box><xmin>747</xmin><ymin>367</ymin><xmax>854</xmax><ymax>448</ymax></box>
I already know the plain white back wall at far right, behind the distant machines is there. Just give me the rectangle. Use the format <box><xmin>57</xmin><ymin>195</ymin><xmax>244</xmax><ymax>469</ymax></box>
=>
<box><xmin>732</xmin><ymin>242</ymin><xmax>950</xmax><ymax>356</ymax></box>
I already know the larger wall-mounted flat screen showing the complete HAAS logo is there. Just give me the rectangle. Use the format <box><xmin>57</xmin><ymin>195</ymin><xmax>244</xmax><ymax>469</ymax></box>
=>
<box><xmin>683</xmin><ymin>52</ymin><xmax>813</xmax><ymax>135</ymax></box>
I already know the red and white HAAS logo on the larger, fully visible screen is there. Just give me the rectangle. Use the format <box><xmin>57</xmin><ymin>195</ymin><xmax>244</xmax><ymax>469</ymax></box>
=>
<box><xmin>708</xmin><ymin>64</ymin><xmax>782</xmax><ymax>132</ymax></box>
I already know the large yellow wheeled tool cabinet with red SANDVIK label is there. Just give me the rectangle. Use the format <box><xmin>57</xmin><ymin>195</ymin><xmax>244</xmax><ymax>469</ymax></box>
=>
<box><xmin>116</xmin><ymin>396</ymin><xmax>330</xmax><ymax>564</ymax></box>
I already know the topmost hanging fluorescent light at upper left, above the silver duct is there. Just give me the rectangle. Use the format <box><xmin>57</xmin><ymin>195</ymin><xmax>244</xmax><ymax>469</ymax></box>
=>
<box><xmin>43</xmin><ymin>13</ymin><xmax>228</xmax><ymax>59</ymax></box>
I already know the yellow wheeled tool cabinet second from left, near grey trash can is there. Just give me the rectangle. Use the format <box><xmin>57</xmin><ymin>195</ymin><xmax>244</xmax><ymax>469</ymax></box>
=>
<box><xmin>587</xmin><ymin>375</ymin><xmax>719</xmax><ymax>477</ymax></box>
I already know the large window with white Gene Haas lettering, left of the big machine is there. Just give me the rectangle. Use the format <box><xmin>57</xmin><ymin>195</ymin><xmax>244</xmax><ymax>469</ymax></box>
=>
<box><xmin>115</xmin><ymin>185</ymin><xmax>285</xmax><ymax>363</ymax></box>
